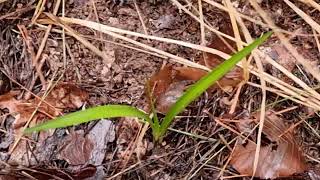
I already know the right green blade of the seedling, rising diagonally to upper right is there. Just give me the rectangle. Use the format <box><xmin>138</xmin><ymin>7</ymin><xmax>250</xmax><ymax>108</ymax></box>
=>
<box><xmin>161</xmin><ymin>32</ymin><xmax>272</xmax><ymax>136</ymax></box>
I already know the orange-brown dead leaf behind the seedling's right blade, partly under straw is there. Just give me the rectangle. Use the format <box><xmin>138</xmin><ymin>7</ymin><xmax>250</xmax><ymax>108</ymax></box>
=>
<box><xmin>148</xmin><ymin>20</ymin><xmax>244</xmax><ymax>113</ymax></box>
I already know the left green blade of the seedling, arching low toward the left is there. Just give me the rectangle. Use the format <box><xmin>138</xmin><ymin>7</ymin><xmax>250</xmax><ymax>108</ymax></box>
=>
<box><xmin>24</xmin><ymin>105</ymin><xmax>152</xmax><ymax>133</ymax></box>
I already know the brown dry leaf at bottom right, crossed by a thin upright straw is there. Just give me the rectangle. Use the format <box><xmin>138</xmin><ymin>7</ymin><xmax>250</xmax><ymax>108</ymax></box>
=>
<box><xmin>230</xmin><ymin>111</ymin><xmax>307</xmax><ymax>179</ymax></box>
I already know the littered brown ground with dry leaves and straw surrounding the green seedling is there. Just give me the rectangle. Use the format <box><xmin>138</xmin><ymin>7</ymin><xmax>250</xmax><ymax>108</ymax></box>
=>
<box><xmin>0</xmin><ymin>0</ymin><xmax>320</xmax><ymax>179</ymax></box>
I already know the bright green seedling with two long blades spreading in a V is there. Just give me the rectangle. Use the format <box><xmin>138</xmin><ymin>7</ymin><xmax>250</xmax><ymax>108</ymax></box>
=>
<box><xmin>25</xmin><ymin>32</ymin><xmax>272</xmax><ymax>141</ymax></box>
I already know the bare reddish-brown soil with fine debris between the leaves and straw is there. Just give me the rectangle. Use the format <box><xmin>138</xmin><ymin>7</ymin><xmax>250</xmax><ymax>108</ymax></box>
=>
<box><xmin>0</xmin><ymin>0</ymin><xmax>320</xmax><ymax>180</ymax></box>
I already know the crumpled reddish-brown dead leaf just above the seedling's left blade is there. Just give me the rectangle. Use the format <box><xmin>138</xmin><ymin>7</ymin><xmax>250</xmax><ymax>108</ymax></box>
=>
<box><xmin>0</xmin><ymin>83</ymin><xmax>88</xmax><ymax>130</ymax></box>
